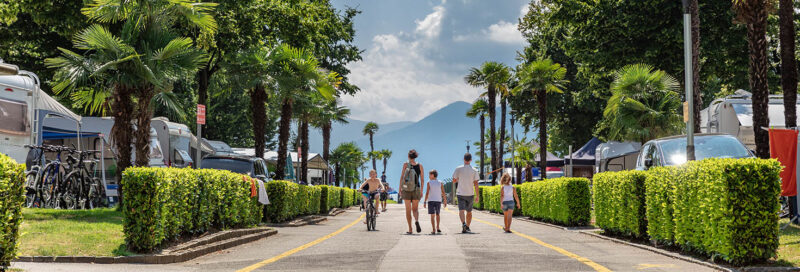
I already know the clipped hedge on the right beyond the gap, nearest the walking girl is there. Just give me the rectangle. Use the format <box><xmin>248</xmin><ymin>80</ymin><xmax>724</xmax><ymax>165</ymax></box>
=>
<box><xmin>521</xmin><ymin>178</ymin><xmax>591</xmax><ymax>226</ymax></box>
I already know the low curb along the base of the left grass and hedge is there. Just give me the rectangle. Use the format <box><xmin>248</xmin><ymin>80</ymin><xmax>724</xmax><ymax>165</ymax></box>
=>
<box><xmin>14</xmin><ymin>228</ymin><xmax>278</xmax><ymax>264</ymax></box>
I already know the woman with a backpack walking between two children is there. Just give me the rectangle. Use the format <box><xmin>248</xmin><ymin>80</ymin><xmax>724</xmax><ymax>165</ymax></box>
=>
<box><xmin>398</xmin><ymin>149</ymin><xmax>425</xmax><ymax>234</ymax></box>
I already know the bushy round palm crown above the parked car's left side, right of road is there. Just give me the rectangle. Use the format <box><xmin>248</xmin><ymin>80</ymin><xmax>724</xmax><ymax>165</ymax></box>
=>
<box><xmin>601</xmin><ymin>64</ymin><xmax>683</xmax><ymax>143</ymax></box>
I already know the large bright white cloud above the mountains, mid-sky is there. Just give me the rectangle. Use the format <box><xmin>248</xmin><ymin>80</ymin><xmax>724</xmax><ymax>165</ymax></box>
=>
<box><xmin>342</xmin><ymin>33</ymin><xmax>479</xmax><ymax>122</ymax></box>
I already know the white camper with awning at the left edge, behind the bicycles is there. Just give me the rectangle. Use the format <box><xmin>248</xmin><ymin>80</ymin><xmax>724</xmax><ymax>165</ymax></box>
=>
<box><xmin>0</xmin><ymin>61</ymin><xmax>81</xmax><ymax>163</ymax></box>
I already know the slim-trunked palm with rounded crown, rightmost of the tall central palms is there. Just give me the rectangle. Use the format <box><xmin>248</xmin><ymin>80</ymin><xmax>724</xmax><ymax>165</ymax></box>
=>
<box><xmin>514</xmin><ymin>59</ymin><xmax>567</xmax><ymax>179</ymax></box>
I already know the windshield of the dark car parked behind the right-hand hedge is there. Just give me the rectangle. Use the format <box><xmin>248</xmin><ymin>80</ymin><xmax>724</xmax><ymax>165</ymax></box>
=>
<box><xmin>660</xmin><ymin>136</ymin><xmax>751</xmax><ymax>165</ymax></box>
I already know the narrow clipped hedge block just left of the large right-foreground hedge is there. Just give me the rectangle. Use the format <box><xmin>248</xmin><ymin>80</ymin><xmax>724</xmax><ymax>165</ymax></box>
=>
<box><xmin>592</xmin><ymin>171</ymin><xmax>647</xmax><ymax>237</ymax></box>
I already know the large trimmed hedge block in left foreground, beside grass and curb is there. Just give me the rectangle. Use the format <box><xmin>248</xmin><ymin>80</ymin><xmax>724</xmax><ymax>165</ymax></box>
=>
<box><xmin>122</xmin><ymin>167</ymin><xmax>261</xmax><ymax>252</ymax></box>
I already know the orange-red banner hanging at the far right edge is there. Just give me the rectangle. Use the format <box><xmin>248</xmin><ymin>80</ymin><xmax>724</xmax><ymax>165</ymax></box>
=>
<box><xmin>769</xmin><ymin>129</ymin><xmax>798</xmax><ymax>196</ymax></box>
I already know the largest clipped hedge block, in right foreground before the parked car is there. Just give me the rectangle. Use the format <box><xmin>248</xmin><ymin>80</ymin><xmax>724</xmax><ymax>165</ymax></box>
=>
<box><xmin>646</xmin><ymin>159</ymin><xmax>781</xmax><ymax>265</ymax></box>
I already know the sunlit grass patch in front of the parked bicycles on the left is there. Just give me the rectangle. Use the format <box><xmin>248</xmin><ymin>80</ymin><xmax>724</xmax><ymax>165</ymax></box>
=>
<box><xmin>18</xmin><ymin>208</ymin><xmax>133</xmax><ymax>256</ymax></box>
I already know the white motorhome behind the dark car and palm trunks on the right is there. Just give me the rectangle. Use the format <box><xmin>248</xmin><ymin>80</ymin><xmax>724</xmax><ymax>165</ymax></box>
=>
<box><xmin>700</xmin><ymin>90</ymin><xmax>800</xmax><ymax>150</ymax></box>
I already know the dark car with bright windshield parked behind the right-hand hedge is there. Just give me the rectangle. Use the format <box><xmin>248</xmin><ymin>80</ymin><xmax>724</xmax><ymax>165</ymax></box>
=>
<box><xmin>636</xmin><ymin>133</ymin><xmax>754</xmax><ymax>170</ymax></box>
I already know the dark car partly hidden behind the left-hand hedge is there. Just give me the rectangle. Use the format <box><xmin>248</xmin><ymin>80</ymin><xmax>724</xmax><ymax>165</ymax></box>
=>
<box><xmin>200</xmin><ymin>154</ymin><xmax>270</xmax><ymax>181</ymax></box>
